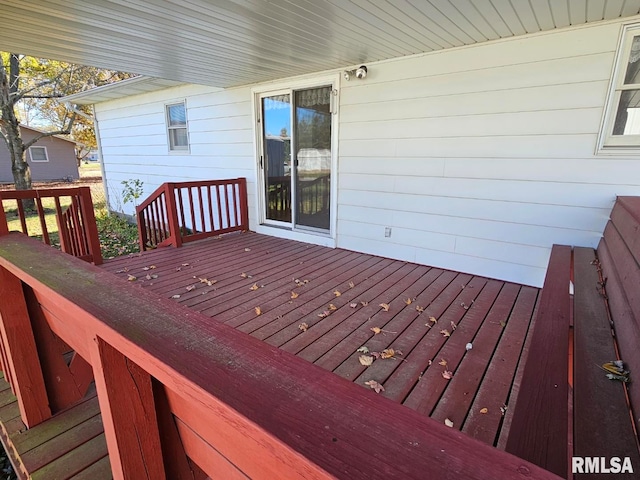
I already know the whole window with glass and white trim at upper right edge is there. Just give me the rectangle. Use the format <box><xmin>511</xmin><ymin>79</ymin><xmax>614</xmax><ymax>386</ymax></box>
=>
<box><xmin>599</xmin><ymin>24</ymin><xmax>640</xmax><ymax>150</ymax></box>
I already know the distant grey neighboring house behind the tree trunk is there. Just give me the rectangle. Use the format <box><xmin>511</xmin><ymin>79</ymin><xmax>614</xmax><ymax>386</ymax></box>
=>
<box><xmin>0</xmin><ymin>125</ymin><xmax>80</xmax><ymax>183</ymax></box>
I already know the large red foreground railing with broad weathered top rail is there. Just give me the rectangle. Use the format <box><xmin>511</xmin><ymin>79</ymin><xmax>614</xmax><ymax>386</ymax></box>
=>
<box><xmin>0</xmin><ymin>234</ymin><xmax>559</xmax><ymax>480</ymax></box>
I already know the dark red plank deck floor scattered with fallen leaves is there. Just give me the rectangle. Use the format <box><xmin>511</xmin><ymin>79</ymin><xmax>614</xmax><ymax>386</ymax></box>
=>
<box><xmin>102</xmin><ymin>233</ymin><xmax>539</xmax><ymax>445</ymax></box>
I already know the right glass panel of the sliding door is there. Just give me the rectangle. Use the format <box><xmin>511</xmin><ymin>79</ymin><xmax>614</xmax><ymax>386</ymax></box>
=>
<box><xmin>294</xmin><ymin>86</ymin><xmax>331</xmax><ymax>230</ymax></box>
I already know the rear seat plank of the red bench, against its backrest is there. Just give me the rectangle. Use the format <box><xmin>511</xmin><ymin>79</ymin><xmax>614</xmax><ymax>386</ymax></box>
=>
<box><xmin>573</xmin><ymin>248</ymin><xmax>640</xmax><ymax>468</ymax></box>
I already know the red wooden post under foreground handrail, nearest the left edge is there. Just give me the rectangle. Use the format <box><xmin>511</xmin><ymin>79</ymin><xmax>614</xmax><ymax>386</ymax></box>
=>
<box><xmin>0</xmin><ymin>267</ymin><xmax>51</xmax><ymax>427</ymax></box>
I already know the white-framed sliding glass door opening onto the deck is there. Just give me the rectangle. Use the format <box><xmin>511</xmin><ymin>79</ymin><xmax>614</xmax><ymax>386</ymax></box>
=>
<box><xmin>260</xmin><ymin>86</ymin><xmax>332</xmax><ymax>232</ymax></box>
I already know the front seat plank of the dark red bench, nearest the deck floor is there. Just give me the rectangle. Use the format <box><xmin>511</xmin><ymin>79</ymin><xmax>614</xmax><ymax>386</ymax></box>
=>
<box><xmin>506</xmin><ymin>245</ymin><xmax>571</xmax><ymax>476</ymax></box>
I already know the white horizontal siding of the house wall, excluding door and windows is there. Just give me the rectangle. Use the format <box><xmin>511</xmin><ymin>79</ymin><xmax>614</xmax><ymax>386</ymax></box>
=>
<box><xmin>96</xmin><ymin>22</ymin><xmax>640</xmax><ymax>286</ymax></box>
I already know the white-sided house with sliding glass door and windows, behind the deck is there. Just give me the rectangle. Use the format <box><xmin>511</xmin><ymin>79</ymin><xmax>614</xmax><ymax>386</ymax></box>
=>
<box><xmin>63</xmin><ymin>11</ymin><xmax>640</xmax><ymax>286</ymax></box>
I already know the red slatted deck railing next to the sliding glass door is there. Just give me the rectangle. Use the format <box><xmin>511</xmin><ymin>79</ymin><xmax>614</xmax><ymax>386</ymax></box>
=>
<box><xmin>136</xmin><ymin>178</ymin><xmax>249</xmax><ymax>250</ymax></box>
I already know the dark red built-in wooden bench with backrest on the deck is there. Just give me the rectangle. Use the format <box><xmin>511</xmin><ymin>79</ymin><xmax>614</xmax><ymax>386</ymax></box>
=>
<box><xmin>505</xmin><ymin>197</ymin><xmax>640</xmax><ymax>478</ymax></box>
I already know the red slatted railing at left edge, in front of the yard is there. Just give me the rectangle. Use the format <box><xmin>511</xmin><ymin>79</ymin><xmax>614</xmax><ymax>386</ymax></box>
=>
<box><xmin>0</xmin><ymin>187</ymin><xmax>102</xmax><ymax>265</ymax></box>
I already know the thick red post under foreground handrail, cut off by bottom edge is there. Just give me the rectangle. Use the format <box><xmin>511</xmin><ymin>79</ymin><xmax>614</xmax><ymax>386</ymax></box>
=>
<box><xmin>91</xmin><ymin>337</ymin><xmax>166</xmax><ymax>480</ymax></box>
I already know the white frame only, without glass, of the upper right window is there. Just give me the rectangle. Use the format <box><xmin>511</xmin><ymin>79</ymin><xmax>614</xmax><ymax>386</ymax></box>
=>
<box><xmin>596</xmin><ymin>23</ymin><xmax>640</xmax><ymax>155</ymax></box>
